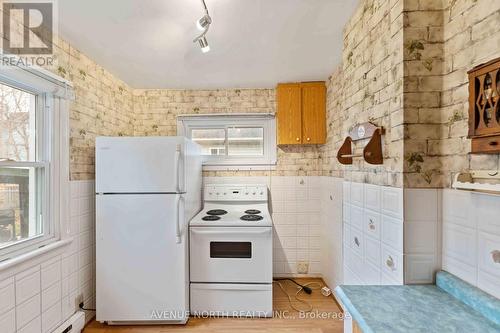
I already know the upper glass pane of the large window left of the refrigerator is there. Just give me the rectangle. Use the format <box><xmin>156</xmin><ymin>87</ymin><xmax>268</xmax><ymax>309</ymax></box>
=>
<box><xmin>0</xmin><ymin>84</ymin><xmax>36</xmax><ymax>161</ymax></box>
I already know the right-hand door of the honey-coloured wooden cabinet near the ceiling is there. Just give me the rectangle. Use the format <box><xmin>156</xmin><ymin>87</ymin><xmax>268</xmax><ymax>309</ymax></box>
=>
<box><xmin>301</xmin><ymin>82</ymin><xmax>326</xmax><ymax>144</ymax></box>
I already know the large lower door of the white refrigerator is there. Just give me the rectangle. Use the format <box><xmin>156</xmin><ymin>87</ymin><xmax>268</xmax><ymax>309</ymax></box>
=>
<box><xmin>96</xmin><ymin>194</ymin><xmax>189</xmax><ymax>322</ymax></box>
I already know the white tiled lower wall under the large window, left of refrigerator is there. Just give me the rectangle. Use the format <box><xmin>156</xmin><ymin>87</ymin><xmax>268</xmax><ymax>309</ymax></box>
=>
<box><xmin>0</xmin><ymin>181</ymin><xmax>95</xmax><ymax>333</ymax></box>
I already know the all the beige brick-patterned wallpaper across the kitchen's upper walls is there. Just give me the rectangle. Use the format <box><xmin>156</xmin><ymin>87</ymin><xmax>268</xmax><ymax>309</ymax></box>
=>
<box><xmin>2</xmin><ymin>0</ymin><xmax>500</xmax><ymax>187</ymax></box>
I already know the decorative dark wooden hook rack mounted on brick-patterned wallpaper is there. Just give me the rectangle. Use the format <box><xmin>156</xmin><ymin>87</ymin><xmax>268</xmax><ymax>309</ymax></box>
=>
<box><xmin>337</xmin><ymin>122</ymin><xmax>385</xmax><ymax>164</ymax></box>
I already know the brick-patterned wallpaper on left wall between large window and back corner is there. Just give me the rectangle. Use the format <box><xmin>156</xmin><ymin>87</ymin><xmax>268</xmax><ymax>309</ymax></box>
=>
<box><xmin>49</xmin><ymin>39</ymin><xmax>134</xmax><ymax>180</ymax></box>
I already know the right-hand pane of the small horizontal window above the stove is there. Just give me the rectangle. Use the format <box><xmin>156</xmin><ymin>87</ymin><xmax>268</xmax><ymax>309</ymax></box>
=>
<box><xmin>227</xmin><ymin>127</ymin><xmax>264</xmax><ymax>156</ymax></box>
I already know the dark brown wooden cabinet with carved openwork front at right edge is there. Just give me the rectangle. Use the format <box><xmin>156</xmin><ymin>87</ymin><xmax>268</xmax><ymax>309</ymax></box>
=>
<box><xmin>468</xmin><ymin>58</ymin><xmax>500</xmax><ymax>154</ymax></box>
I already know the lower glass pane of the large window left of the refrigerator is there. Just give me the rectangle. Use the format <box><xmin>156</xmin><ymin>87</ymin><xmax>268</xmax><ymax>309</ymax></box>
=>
<box><xmin>0</xmin><ymin>167</ymin><xmax>43</xmax><ymax>248</ymax></box>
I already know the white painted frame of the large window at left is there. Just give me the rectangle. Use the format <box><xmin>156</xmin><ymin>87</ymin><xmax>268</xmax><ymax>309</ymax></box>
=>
<box><xmin>0</xmin><ymin>66</ymin><xmax>70</xmax><ymax>264</ymax></box>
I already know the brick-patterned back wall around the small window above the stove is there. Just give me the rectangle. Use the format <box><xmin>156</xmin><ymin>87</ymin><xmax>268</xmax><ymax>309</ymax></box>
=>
<box><xmin>134</xmin><ymin>89</ymin><xmax>321</xmax><ymax>176</ymax></box>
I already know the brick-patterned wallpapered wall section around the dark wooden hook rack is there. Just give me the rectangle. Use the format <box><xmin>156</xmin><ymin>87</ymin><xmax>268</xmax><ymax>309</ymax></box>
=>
<box><xmin>320</xmin><ymin>0</ymin><xmax>404</xmax><ymax>187</ymax></box>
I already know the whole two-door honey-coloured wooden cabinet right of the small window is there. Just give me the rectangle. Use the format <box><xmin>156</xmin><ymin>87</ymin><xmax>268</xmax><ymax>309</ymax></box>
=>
<box><xmin>276</xmin><ymin>82</ymin><xmax>326</xmax><ymax>145</ymax></box>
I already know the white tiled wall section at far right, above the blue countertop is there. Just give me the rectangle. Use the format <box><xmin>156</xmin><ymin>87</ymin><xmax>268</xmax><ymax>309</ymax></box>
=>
<box><xmin>442</xmin><ymin>189</ymin><xmax>500</xmax><ymax>298</ymax></box>
